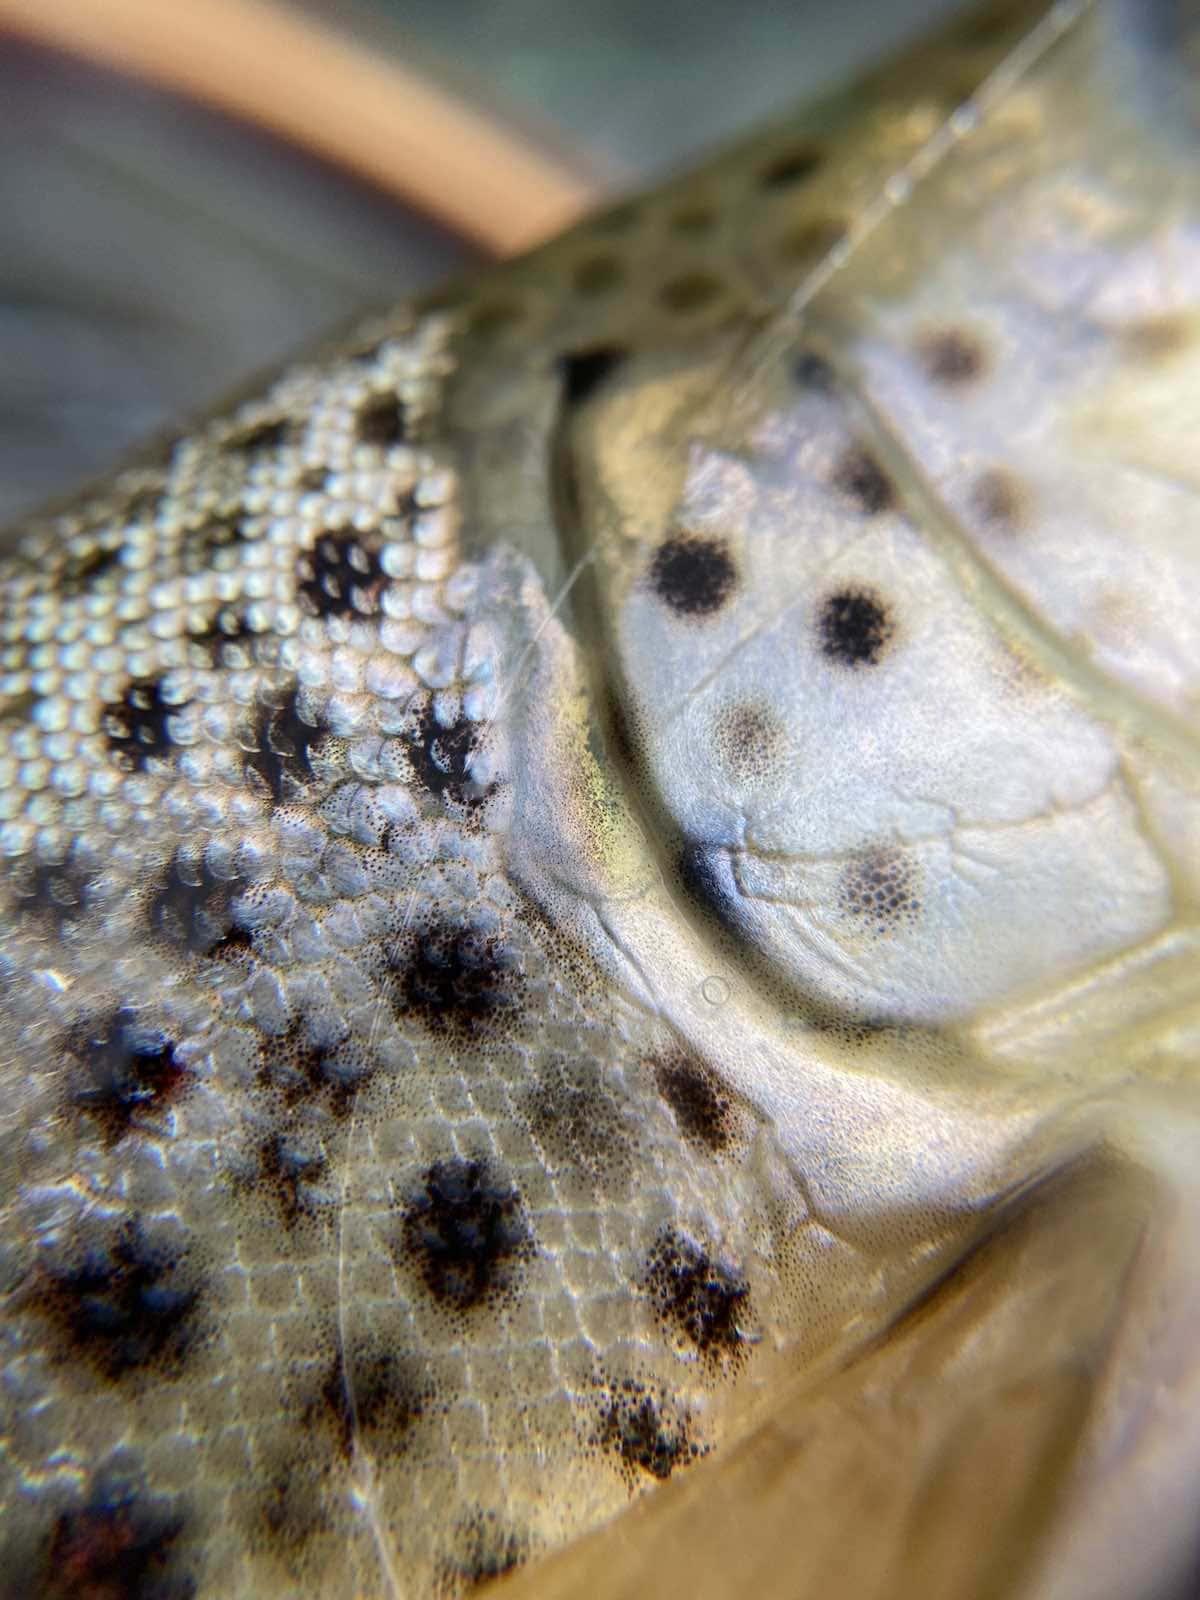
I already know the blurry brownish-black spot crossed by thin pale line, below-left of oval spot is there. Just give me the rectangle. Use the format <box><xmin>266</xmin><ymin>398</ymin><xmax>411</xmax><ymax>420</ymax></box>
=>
<box><xmin>315</xmin><ymin>1344</ymin><xmax>434</xmax><ymax>1461</ymax></box>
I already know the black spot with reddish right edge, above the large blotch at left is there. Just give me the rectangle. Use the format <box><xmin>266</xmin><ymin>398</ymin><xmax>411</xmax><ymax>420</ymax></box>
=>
<box><xmin>67</xmin><ymin>1005</ymin><xmax>187</xmax><ymax>1142</ymax></box>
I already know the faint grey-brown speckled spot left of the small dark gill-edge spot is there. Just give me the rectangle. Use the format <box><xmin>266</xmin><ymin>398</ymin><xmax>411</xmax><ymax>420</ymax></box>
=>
<box><xmin>523</xmin><ymin>1056</ymin><xmax>637</xmax><ymax>1184</ymax></box>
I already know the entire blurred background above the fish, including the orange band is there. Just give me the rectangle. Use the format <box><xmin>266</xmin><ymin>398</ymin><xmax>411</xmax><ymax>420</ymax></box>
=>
<box><xmin>0</xmin><ymin>0</ymin><xmax>968</xmax><ymax>523</ymax></box>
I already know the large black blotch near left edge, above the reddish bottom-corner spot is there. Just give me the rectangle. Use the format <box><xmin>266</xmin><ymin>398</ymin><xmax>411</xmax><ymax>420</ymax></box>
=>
<box><xmin>30</xmin><ymin>1218</ymin><xmax>202</xmax><ymax>1381</ymax></box>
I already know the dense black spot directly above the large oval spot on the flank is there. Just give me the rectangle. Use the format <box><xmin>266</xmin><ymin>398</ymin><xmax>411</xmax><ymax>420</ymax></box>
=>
<box><xmin>392</xmin><ymin>922</ymin><xmax>525</xmax><ymax>1035</ymax></box>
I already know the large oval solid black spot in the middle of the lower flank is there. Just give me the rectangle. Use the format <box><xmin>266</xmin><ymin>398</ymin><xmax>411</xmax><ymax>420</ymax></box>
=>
<box><xmin>403</xmin><ymin>1157</ymin><xmax>533</xmax><ymax>1312</ymax></box>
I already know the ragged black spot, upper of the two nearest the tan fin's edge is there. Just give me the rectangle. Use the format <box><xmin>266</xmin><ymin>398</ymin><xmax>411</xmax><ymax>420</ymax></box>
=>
<box><xmin>642</xmin><ymin>1227</ymin><xmax>750</xmax><ymax>1366</ymax></box>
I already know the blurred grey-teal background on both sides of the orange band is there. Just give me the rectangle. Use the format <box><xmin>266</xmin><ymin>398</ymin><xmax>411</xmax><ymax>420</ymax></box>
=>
<box><xmin>0</xmin><ymin>0</ymin><xmax>963</xmax><ymax>523</ymax></box>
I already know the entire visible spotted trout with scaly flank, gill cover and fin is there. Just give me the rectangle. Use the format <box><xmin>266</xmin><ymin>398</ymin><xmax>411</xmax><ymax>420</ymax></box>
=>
<box><xmin>0</xmin><ymin>0</ymin><xmax>1200</xmax><ymax>1600</ymax></box>
